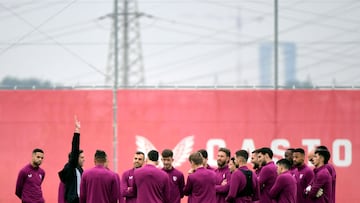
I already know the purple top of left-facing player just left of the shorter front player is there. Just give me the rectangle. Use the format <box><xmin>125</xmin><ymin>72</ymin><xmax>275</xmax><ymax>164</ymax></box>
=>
<box><xmin>258</xmin><ymin>161</ymin><xmax>277</xmax><ymax>203</ymax></box>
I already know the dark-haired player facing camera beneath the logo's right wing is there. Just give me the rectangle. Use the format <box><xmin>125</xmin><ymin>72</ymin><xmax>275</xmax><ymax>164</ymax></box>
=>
<box><xmin>161</xmin><ymin>149</ymin><xmax>185</xmax><ymax>203</ymax></box>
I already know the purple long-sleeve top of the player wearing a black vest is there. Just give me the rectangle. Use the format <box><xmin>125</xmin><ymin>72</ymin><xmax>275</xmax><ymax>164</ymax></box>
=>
<box><xmin>226</xmin><ymin>166</ymin><xmax>260</xmax><ymax>203</ymax></box>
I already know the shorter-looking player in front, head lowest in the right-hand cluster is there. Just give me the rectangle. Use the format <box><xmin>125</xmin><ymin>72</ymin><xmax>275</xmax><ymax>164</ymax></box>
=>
<box><xmin>269</xmin><ymin>159</ymin><xmax>297</xmax><ymax>203</ymax></box>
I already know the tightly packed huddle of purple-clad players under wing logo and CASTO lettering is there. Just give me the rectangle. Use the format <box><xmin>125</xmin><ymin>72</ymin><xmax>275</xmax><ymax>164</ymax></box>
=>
<box><xmin>121</xmin><ymin>146</ymin><xmax>336</xmax><ymax>203</ymax></box>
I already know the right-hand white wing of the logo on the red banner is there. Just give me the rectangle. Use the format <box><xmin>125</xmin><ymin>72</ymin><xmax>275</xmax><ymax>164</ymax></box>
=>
<box><xmin>173</xmin><ymin>136</ymin><xmax>194</xmax><ymax>168</ymax></box>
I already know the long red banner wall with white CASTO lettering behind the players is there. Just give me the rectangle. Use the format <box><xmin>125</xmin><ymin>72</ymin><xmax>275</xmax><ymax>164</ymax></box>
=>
<box><xmin>0</xmin><ymin>90</ymin><xmax>360</xmax><ymax>202</ymax></box>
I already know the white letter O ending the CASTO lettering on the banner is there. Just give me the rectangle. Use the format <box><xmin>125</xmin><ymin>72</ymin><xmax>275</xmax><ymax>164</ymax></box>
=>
<box><xmin>333</xmin><ymin>139</ymin><xmax>352</xmax><ymax>167</ymax></box>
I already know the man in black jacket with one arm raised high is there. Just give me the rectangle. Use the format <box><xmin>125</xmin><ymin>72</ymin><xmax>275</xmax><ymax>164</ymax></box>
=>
<box><xmin>58</xmin><ymin>117</ymin><xmax>85</xmax><ymax>203</ymax></box>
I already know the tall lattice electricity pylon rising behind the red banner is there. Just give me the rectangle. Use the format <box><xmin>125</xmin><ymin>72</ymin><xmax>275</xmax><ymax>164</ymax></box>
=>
<box><xmin>105</xmin><ymin>0</ymin><xmax>145</xmax><ymax>87</ymax></box>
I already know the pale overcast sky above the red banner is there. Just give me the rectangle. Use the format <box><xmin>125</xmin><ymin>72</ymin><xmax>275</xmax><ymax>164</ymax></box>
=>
<box><xmin>0</xmin><ymin>0</ymin><xmax>360</xmax><ymax>88</ymax></box>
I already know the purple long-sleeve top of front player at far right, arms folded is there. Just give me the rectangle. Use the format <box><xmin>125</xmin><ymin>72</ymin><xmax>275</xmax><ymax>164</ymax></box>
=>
<box><xmin>307</xmin><ymin>165</ymin><xmax>333</xmax><ymax>203</ymax></box>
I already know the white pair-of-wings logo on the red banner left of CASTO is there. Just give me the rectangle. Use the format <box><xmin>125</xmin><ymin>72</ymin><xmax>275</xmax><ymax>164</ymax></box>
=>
<box><xmin>135</xmin><ymin>135</ymin><xmax>194</xmax><ymax>168</ymax></box>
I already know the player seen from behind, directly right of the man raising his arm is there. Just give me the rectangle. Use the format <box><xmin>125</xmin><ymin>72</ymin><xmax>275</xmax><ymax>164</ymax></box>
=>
<box><xmin>80</xmin><ymin>150</ymin><xmax>122</xmax><ymax>203</ymax></box>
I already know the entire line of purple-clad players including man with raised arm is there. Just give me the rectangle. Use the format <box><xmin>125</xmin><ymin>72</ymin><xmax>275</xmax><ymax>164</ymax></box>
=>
<box><xmin>16</xmin><ymin>117</ymin><xmax>336</xmax><ymax>203</ymax></box>
